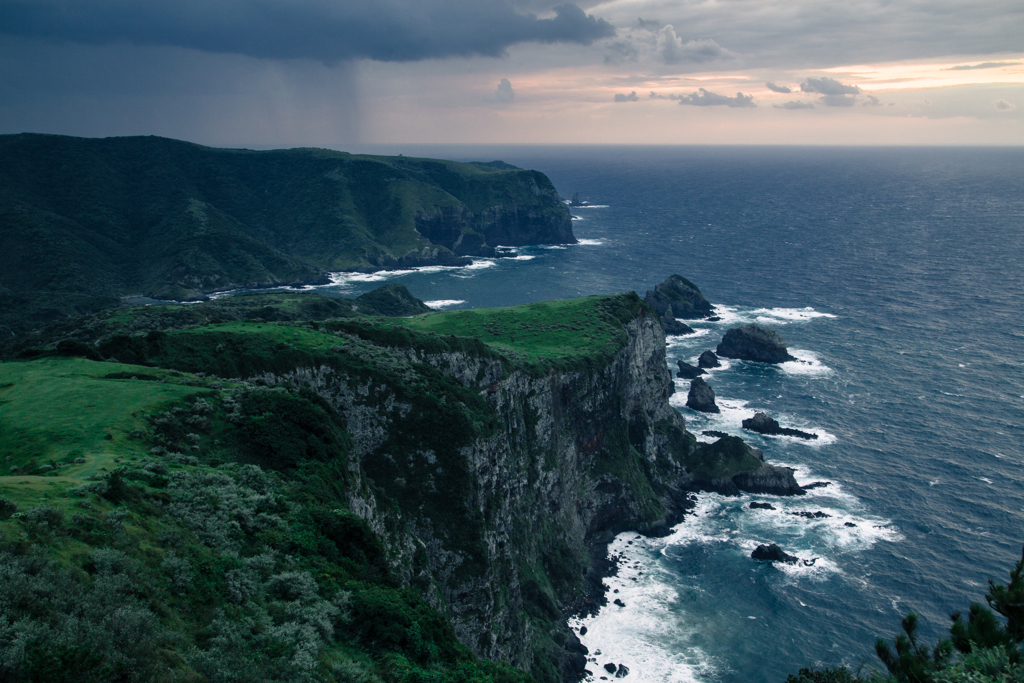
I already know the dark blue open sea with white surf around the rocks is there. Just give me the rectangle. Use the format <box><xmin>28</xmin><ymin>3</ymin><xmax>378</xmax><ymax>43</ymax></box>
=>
<box><xmin>288</xmin><ymin>145</ymin><xmax>1024</xmax><ymax>683</ymax></box>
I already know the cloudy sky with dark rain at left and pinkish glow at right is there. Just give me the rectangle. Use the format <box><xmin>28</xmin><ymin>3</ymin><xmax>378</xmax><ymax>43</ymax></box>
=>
<box><xmin>0</xmin><ymin>0</ymin><xmax>1024</xmax><ymax>144</ymax></box>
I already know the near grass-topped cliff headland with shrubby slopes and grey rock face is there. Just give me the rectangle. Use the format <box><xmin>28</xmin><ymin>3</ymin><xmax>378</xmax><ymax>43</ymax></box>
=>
<box><xmin>0</xmin><ymin>291</ymin><xmax>798</xmax><ymax>683</ymax></box>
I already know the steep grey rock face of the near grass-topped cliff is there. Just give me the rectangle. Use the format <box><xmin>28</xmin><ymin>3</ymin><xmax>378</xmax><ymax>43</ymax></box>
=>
<box><xmin>254</xmin><ymin>301</ymin><xmax>693</xmax><ymax>681</ymax></box>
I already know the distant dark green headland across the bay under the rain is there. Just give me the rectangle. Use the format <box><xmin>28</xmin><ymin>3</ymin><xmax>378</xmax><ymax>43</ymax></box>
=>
<box><xmin>0</xmin><ymin>134</ymin><xmax>575</xmax><ymax>334</ymax></box>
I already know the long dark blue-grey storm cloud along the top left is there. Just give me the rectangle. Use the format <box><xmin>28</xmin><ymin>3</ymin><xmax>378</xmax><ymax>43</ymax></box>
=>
<box><xmin>0</xmin><ymin>0</ymin><xmax>615</xmax><ymax>62</ymax></box>
